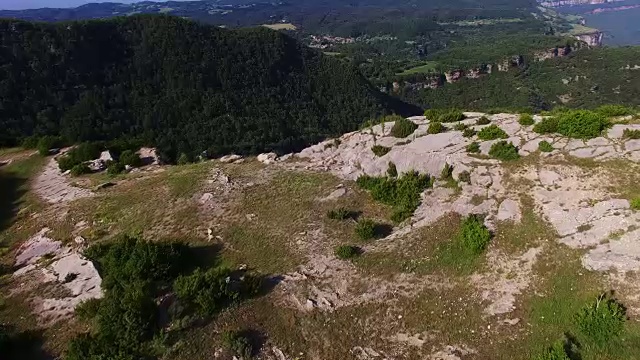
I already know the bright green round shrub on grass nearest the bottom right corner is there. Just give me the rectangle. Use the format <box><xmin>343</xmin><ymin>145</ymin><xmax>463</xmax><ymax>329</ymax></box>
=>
<box><xmin>575</xmin><ymin>294</ymin><xmax>626</xmax><ymax>347</ymax></box>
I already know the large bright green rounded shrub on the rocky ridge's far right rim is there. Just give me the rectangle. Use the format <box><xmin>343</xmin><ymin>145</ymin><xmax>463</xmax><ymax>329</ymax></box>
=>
<box><xmin>558</xmin><ymin>110</ymin><xmax>610</xmax><ymax>139</ymax></box>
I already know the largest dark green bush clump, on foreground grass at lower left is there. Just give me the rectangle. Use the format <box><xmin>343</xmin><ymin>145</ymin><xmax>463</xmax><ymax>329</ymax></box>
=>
<box><xmin>66</xmin><ymin>237</ymin><xmax>261</xmax><ymax>360</ymax></box>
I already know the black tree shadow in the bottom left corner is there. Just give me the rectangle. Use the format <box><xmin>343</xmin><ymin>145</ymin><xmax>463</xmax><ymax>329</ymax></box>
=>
<box><xmin>0</xmin><ymin>327</ymin><xmax>54</xmax><ymax>360</ymax></box>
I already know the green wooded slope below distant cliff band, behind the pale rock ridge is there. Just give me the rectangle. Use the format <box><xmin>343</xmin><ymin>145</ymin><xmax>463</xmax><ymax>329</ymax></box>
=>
<box><xmin>402</xmin><ymin>47</ymin><xmax>640</xmax><ymax>110</ymax></box>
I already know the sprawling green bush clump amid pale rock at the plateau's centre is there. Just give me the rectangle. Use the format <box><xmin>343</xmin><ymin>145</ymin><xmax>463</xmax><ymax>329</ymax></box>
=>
<box><xmin>356</xmin><ymin>171</ymin><xmax>432</xmax><ymax>222</ymax></box>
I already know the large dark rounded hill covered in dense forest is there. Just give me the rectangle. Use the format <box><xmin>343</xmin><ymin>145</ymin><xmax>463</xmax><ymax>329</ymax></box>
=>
<box><xmin>0</xmin><ymin>15</ymin><xmax>419</xmax><ymax>158</ymax></box>
